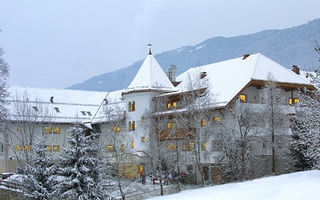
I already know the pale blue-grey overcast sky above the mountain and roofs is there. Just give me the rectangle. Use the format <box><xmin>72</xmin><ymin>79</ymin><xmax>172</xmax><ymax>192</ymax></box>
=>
<box><xmin>0</xmin><ymin>0</ymin><xmax>320</xmax><ymax>88</ymax></box>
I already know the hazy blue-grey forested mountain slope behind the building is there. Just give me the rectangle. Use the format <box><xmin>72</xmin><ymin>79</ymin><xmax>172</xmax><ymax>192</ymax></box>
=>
<box><xmin>68</xmin><ymin>19</ymin><xmax>320</xmax><ymax>91</ymax></box>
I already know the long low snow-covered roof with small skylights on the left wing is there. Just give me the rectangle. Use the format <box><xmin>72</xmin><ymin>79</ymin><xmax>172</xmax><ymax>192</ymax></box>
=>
<box><xmin>8</xmin><ymin>87</ymin><xmax>108</xmax><ymax>123</ymax></box>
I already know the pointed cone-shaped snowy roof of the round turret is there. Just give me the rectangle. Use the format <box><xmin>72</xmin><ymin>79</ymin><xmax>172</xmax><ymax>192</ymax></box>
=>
<box><xmin>126</xmin><ymin>55</ymin><xmax>176</xmax><ymax>92</ymax></box>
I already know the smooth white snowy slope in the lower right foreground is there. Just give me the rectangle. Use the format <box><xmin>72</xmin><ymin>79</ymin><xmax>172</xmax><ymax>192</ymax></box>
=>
<box><xmin>149</xmin><ymin>170</ymin><xmax>320</xmax><ymax>200</ymax></box>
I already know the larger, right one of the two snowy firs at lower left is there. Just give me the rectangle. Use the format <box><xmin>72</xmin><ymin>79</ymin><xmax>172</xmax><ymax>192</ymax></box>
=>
<box><xmin>54</xmin><ymin>125</ymin><xmax>102</xmax><ymax>200</ymax></box>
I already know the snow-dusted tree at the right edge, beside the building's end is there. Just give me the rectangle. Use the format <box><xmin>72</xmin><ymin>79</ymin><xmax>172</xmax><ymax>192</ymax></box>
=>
<box><xmin>291</xmin><ymin>71</ymin><xmax>320</xmax><ymax>170</ymax></box>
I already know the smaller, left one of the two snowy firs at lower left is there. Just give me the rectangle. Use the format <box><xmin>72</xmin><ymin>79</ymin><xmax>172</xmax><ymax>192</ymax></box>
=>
<box><xmin>23</xmin><ymin>137</ymin><xmax>57</xmax><ymax>200</ymax></box>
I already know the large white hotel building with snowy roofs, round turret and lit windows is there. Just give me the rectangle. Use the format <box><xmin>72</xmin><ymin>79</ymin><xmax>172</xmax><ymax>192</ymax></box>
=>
<box><xmin>0</xmin><ymin>49</ymin><xmax>313</xmax><ymax>182</ymax></box>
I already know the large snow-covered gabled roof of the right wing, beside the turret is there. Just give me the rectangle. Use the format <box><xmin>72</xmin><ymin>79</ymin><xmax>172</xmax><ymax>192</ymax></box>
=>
<box><xmin>177</xmin><ymin>53</ymin><xmax>310</xmax><ymax>105</ymax></box>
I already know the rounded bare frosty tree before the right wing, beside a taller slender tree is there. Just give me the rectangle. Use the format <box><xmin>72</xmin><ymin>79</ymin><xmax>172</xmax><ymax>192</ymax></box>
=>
<box><xmin>217</xmin><ymin>104</ymin><xmax>261</xmax><ymax>182</ymax></box>
